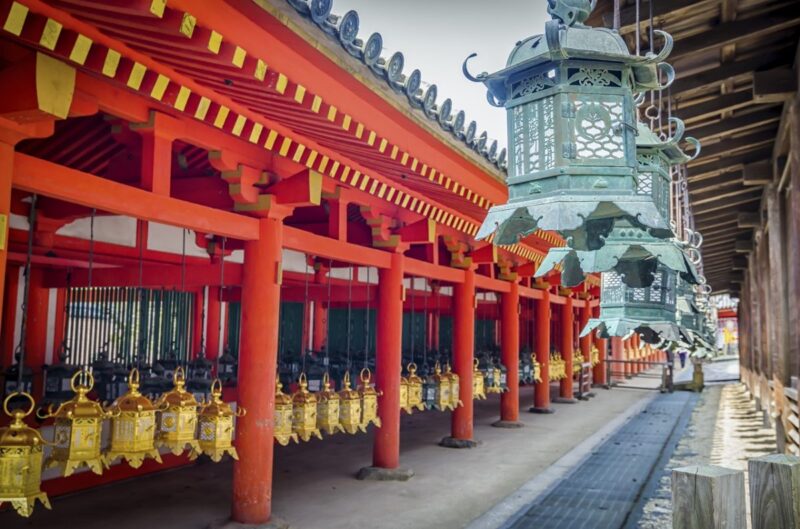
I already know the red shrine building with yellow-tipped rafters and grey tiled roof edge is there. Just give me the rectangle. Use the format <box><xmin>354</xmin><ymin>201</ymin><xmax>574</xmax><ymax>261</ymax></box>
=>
<box><xmin>0</xmin><ymin>0</ymin><xmax>663</xmax><ymax>523</ymax></box>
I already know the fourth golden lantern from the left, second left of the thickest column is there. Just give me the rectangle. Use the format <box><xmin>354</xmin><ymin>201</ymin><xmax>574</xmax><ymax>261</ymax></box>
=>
<box><xmin>156</xmin><ymin>366</ymin><xmax>200</xmax><ymax>459</ymax></box>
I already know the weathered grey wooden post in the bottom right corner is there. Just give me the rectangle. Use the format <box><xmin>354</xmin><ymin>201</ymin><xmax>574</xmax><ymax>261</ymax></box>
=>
<box><xmin>747</xmin><ymin>454</ymin><xmax>800</xmax><ymax>529</ymax></box>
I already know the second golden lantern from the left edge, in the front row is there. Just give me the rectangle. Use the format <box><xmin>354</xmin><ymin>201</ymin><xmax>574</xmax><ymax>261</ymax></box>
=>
<box><xmin>39</xmin><ymin>370</ymin><xmax>109</xmax><ymax>477</ymax></box>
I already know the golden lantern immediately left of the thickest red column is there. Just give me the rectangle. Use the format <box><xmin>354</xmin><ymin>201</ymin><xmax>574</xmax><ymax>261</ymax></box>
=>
<box><xmin>196</xmin><ymin>379</ymin><xmax>247</xmax><ymax>463</ymax></box>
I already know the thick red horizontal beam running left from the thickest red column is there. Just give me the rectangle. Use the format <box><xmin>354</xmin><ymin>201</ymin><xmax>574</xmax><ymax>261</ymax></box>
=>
<box><xmin>12</xmin><ymin>153</ymin><xmax>258</xmax><ymax>240</ymax></box>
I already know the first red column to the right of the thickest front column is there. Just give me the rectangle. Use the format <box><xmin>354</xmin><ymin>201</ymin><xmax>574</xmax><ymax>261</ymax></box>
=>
<box><xmin>372</xmin><ymin>253</ymin><xmax>403</xmax><ymax>469</ymax></box>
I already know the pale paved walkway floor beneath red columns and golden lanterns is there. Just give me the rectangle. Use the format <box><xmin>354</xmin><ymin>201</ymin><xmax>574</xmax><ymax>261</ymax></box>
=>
<box><xmin>0</xmin><ymin>380</ymin><xmax>658</xmax><ymax>529</ymax></box>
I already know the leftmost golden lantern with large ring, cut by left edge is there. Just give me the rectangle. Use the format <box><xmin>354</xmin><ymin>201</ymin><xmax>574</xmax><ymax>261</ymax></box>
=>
<box><xmin>0</xmin><ymin>391</ymin><xmax>50</xmax><ymax>518</ymax></box>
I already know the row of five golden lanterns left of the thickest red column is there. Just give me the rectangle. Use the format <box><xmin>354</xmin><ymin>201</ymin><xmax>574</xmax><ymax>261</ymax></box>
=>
<box><xmin>0</xmin><ymin>367</ymin><xmax>244</xmax><ymax>517</ymax></box>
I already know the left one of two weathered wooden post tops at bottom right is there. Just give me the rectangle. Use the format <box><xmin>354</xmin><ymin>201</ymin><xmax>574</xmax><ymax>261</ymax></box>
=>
<box><xmin>672</xmin><ymin>465</ymin><xmax>747</xmax><ymax>529</ymax></box>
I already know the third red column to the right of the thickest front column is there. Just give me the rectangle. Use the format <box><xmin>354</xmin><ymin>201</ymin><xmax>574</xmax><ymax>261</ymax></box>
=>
<box><xmin>493</xmin><ymin>281</ymin><xmax>522</xmax><ymax>428</ymax></box>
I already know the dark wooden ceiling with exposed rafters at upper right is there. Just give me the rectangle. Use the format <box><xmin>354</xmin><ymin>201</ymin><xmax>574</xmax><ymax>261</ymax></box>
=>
<box><xmin>588</xmin><ymin>0</ymin><xmax>800</xmax><ymax>292</ymax></box>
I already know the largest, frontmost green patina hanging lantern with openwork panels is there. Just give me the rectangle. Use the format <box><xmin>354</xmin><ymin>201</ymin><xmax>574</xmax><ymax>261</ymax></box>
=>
<box><xmin>463</xmin><ymin>0</ymin><xmax>674</xmax><ymax>250</ymax></box>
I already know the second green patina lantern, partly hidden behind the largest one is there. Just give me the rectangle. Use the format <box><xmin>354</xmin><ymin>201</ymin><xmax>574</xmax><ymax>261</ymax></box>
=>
<box><xmin>536</xmin><ymin>118</ymin><xmax>702</xmax><ymax>287</ymax></box>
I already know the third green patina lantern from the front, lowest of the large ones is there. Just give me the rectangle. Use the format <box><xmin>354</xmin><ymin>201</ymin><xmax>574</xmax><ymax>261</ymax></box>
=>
<box><xmin>581</xmin><ymin>266</ymin><xmax>684</xmax><ymax>343</ymax></box>
